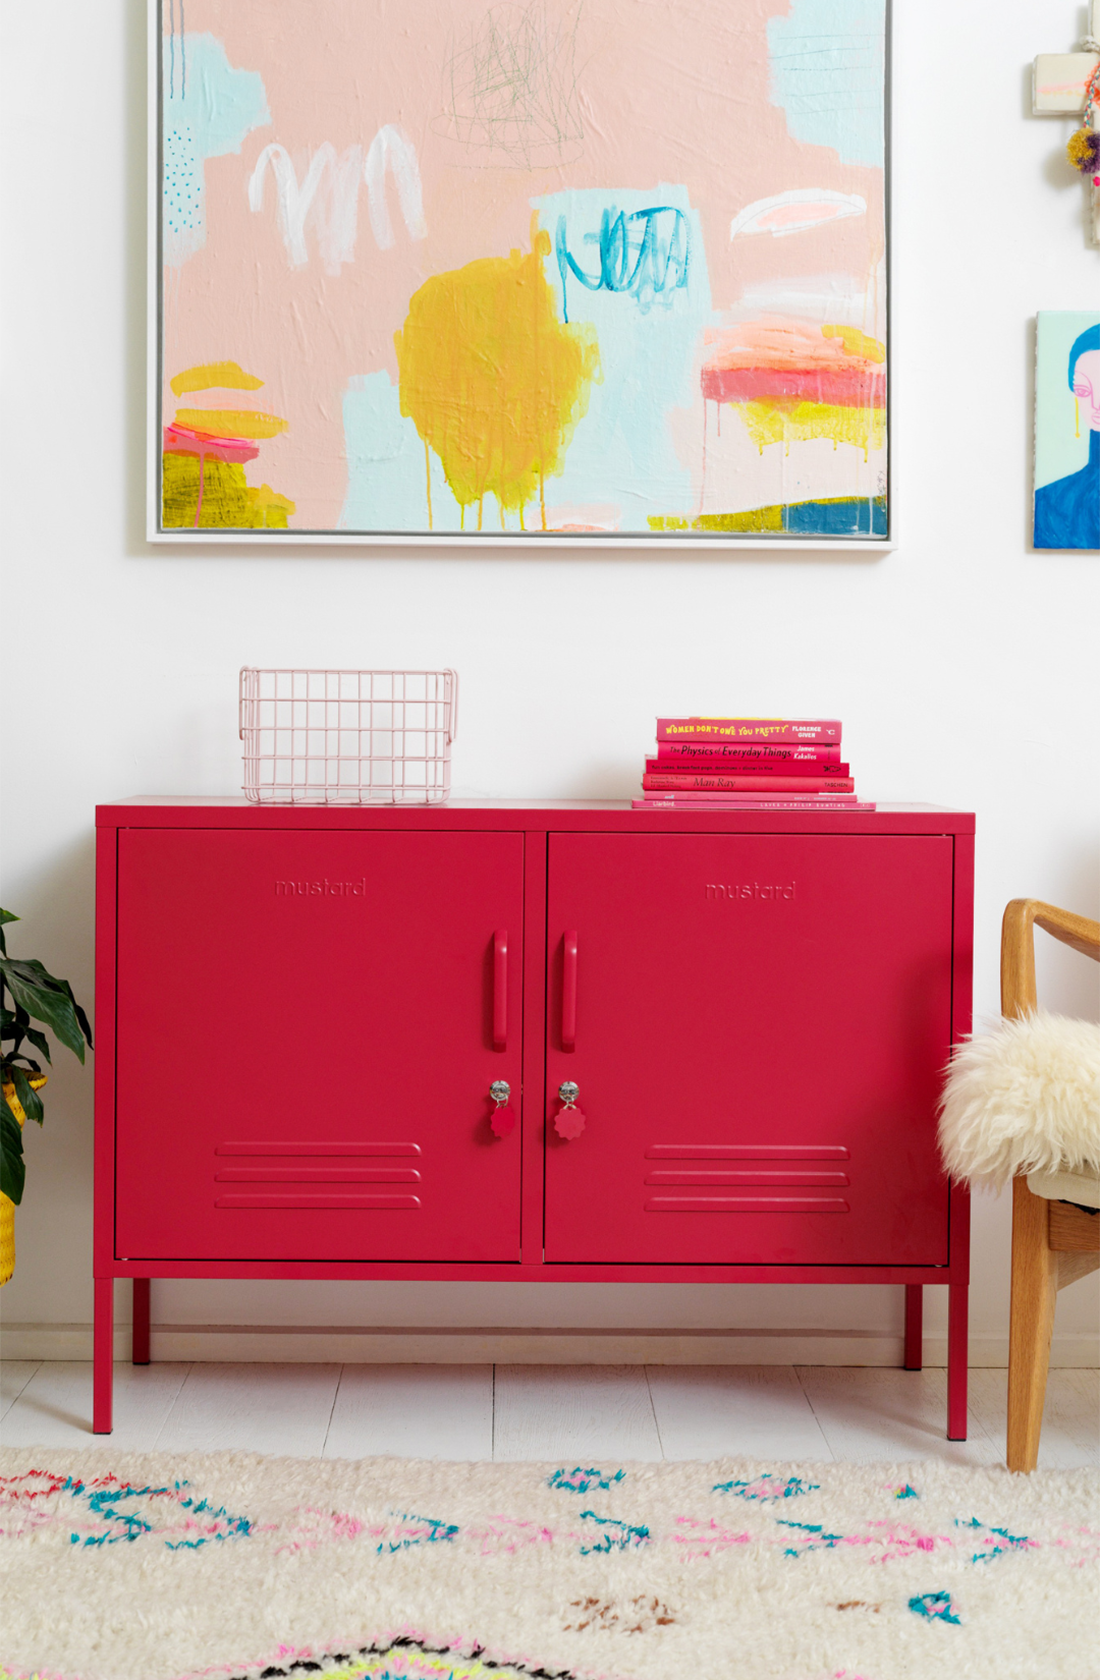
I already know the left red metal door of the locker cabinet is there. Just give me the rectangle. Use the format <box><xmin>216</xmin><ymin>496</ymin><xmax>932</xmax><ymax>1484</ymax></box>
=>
<box><xmin>116</xmin><ymin>830</ymin><xmax>524</xmax><ymax>1262</ymax></box>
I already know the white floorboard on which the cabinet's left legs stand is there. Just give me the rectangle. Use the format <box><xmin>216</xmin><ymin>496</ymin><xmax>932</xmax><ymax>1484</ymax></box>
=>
<box><xmin>0</xmin><ymin>1359</ymin><xmax>188</xmax><ymax>1453</ymax></box>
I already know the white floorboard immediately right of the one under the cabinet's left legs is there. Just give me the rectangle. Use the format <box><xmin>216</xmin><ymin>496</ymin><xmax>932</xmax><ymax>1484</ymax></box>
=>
<box><xmin>156</xmin><ymin>1364</ymin><xmax>341</xmax><ymax>1458</ymax></box>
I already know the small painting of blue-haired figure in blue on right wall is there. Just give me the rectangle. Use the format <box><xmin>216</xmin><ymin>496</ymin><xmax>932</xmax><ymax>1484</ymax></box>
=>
<box><xmin>1035</xmin><ymin>309</ymin><xmax>1100</xmax><ymax>548</ymax></box>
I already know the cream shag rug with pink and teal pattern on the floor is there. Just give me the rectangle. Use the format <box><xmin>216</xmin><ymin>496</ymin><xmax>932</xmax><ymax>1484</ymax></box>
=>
<box><xmin>0</xmin><ymin>1448</ymin><xmax>1100</xmax><ymax>1680</ymax></box>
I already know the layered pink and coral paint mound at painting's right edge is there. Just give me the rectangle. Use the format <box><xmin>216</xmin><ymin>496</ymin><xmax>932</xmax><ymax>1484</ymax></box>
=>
<box><xmin>700</xmin><ymin>318</ymin><xmax>887</xmax><ymax>408</ymax></box>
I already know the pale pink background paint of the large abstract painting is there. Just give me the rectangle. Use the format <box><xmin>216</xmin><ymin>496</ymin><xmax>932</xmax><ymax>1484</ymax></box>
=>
<box><xmin>163</xmin><ymin>0</ymin><xmax>885</xmax><ymax>531</ymax></box>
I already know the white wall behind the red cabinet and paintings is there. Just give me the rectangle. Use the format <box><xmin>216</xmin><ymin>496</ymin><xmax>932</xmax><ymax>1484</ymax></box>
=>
<box><xmin>0</xmin><ymin>0</ymin><xmax>1100</xmax><ymax>1364</ymax></box>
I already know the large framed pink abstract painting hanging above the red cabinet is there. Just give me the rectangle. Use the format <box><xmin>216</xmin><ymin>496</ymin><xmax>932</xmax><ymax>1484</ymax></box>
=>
<box><xmin>149</xmin><ymin>0</ymin><xmax>888</xmax><ymax>548</ymax></box>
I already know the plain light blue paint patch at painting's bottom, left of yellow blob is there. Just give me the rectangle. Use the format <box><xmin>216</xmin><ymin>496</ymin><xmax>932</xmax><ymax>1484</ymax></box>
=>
<box><xmin>339</xmin><ymin>373</ymin><xmax>466</xmax><ymax>531</ymax></box>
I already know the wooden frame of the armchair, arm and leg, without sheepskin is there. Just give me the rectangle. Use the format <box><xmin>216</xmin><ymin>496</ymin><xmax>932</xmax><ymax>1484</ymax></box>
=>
<box><xmin>1001</xmin><ymin>899</ymin><xmax>1100</xmax><ymax>1470</ymax></box>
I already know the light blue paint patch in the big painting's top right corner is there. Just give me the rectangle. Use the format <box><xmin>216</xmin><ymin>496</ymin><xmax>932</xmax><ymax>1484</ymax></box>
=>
<box><xmin>767</xmin><ymin>0</ymin><xmax>887</xmax><ymax>168</ymax></box>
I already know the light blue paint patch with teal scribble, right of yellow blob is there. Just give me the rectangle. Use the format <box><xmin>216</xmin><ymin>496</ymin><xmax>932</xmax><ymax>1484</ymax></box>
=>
<box><xmin>531</xmin><ymin>181</ymin><xmax>715</xmax><ymax>531</ymax></box>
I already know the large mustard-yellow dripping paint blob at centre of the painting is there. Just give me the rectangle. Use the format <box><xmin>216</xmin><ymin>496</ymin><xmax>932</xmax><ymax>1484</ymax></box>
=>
<box><xmin>395</xmin><ymin>217</ymin><xmax>600</xmax><ymax>531</ymax></box>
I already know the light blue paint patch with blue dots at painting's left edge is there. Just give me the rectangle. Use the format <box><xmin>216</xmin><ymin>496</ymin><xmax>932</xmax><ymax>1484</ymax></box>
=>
<box><xmin>161</xmin><ymin>35</ymin><xmax>270</xmax><ymax>267</ymax></box>
